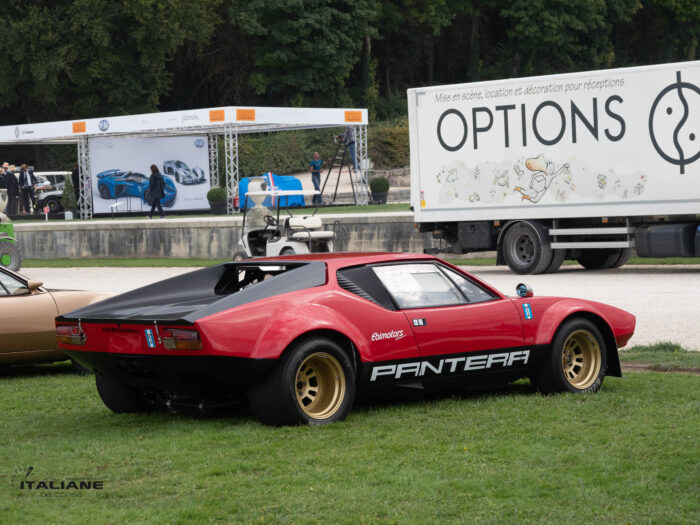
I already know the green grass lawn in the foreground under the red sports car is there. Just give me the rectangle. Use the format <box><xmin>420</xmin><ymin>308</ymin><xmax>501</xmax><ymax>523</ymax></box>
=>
<box><xmin>0</xmin><ymin>365</ymin><xmax>700</xmax><ymax>524</ymax></box>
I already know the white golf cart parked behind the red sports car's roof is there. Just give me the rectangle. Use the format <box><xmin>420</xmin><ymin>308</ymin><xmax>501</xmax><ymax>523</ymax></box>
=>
<box><xmin>233</xmin><ymin>181</ymin><xmax>335</xmax><ymax>261</ymax></box>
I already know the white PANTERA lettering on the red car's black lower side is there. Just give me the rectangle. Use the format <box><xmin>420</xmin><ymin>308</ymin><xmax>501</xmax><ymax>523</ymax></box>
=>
<box><xmin>369</xmin><ymin>349</ymin><xmax>530</xmax><ymax>383</ymax></box>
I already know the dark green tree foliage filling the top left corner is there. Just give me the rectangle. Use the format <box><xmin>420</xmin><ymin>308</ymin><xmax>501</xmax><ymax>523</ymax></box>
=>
<box><xmin>0</xmin><ymin>0</ymin><xmax>220</xmax><ymax>122</ymax></box>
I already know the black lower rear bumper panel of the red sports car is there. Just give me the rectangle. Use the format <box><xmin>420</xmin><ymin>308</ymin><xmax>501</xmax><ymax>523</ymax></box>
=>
<box><xmin>65</xmin><ymin>350</ymin><xmax>277</xmax><ymax>393</ymax></box>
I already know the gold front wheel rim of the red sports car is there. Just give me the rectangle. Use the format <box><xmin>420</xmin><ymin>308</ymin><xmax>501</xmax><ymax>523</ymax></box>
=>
<box><xmin>561</xmin><ymin>330</ymin><xmax>602</xmax><ymax>390</ymax></box>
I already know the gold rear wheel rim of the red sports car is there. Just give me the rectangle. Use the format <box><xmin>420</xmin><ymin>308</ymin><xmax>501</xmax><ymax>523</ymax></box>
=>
<box><xmin>295</xmin><ymin>352</ymin><xmax>345</xmax><ymax>419</ymax></box>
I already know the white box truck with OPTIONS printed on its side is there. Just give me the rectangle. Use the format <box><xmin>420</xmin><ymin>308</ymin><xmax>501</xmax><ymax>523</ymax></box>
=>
<box><xmin>408</xmin><ymin>61</ymin><xmax>700</xmax><ymax>274</ymax></box>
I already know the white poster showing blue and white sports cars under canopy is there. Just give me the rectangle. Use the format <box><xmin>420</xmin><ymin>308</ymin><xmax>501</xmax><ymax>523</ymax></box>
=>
<box><xmin>90</xmin><ymin>135</ymin><xmax>210</xmax><ymax>213</ymax></box>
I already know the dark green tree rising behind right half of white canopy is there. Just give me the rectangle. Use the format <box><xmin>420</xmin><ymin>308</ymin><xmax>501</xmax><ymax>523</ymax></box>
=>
<box><xmin>230</xmin><ymin>0</ymin><xmax>377</xmax><ymax>104</ymax></box>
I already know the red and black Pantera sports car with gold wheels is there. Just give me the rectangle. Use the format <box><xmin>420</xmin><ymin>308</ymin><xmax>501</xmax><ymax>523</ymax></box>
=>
<box><xmin>56</xmin><ymin>253</ymin><xmax>635</xmax><ymax>425</ymax></box>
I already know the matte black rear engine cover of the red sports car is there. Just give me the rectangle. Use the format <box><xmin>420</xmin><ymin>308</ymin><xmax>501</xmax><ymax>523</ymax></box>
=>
<box><xmin>57</xmin><ymin>260</ymin><xmax>326</xmax><ymax>324</ymax></box>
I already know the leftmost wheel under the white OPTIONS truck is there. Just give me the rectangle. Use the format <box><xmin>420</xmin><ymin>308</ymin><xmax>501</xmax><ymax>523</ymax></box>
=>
<box><xmin>501</xmin><ymin>221</ymin><xmax>554</xmax><ymax>274</ymax></box>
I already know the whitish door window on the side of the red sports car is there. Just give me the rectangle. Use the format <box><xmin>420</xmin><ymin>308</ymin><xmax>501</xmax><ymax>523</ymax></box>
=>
<box><xmin>372</xmin><ymin>263</ymin><xmax>467</xmax><ymax>309</ymax></box>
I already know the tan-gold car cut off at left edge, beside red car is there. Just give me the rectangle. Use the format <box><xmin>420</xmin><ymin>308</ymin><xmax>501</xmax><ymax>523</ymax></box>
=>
<box><xmin>0</xmin><ymin>266</ymin><xmax>112</xmax><ymax>365</ymax></box>
